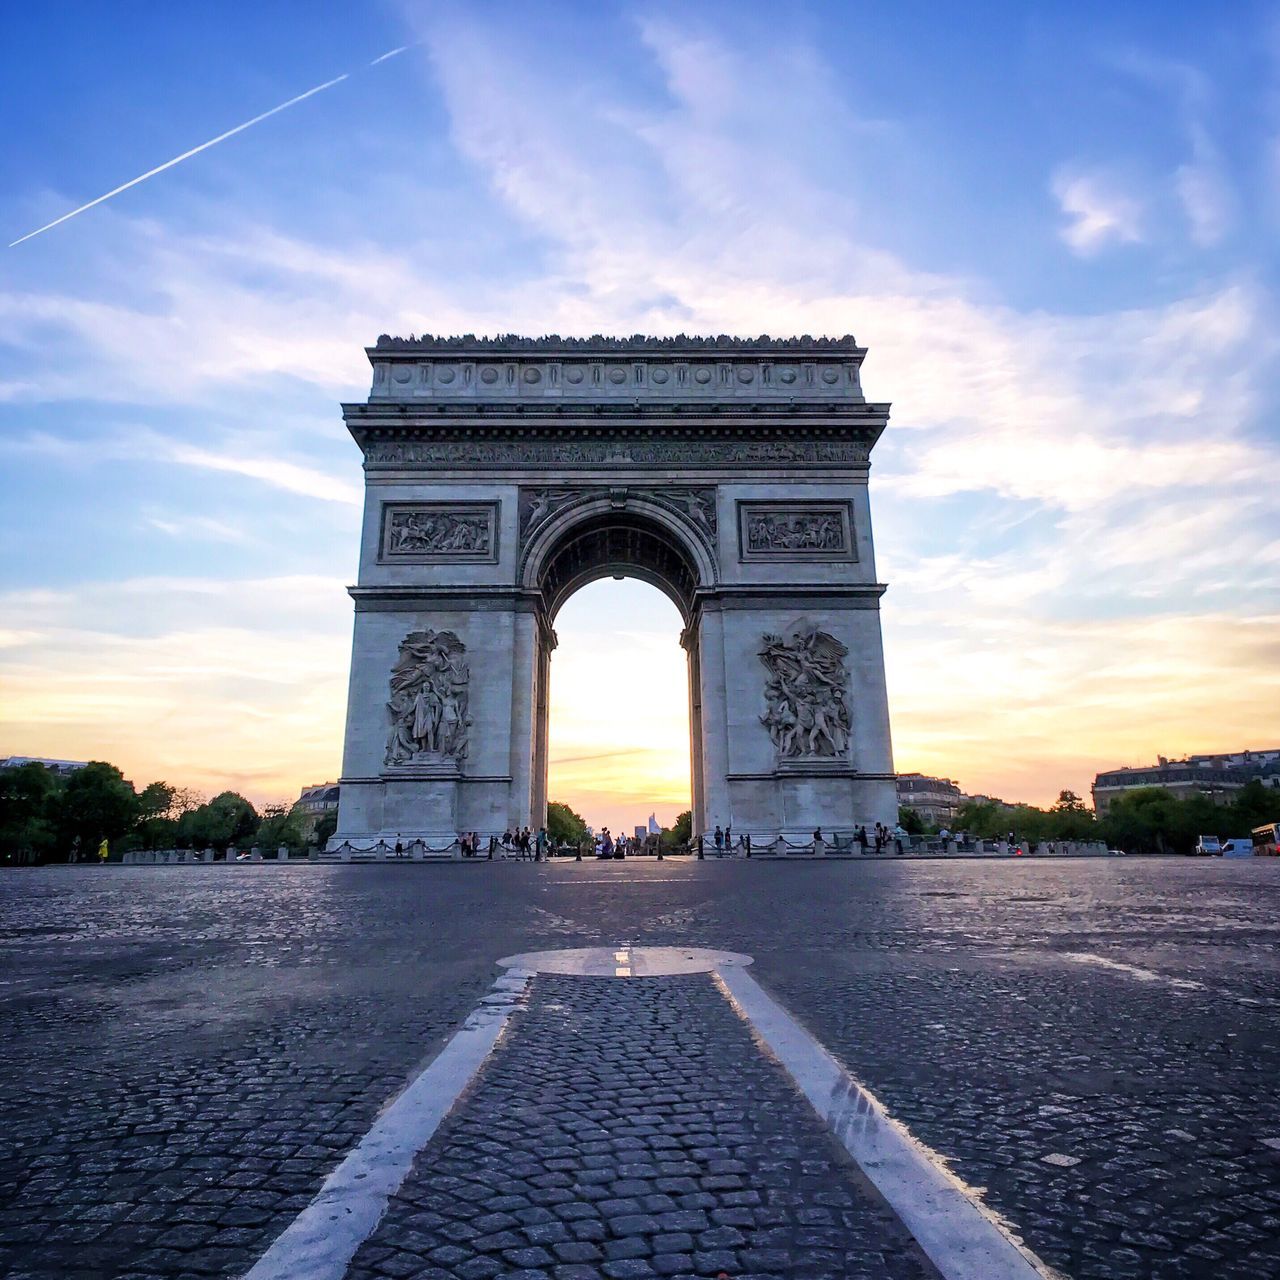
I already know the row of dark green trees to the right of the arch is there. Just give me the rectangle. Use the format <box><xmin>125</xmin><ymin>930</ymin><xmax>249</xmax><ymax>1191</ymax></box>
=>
<box><xmin>899</xmin><ymin>778</ymin><xmax>1280</xmax><ymax>854</ymax></box>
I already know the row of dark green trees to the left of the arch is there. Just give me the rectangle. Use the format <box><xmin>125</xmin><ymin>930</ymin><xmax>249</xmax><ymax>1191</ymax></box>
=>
<box><xmin>0</xmin><ymin>760</ymin><xmax>325</xmax><ymax>864</ymax></box>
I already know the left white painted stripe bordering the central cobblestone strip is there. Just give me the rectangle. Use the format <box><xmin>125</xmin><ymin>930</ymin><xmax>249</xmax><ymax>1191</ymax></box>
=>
<box><xmin>244</xmin><ymin>969</ymin><xmax>534</xmax><ymax>1280</ymax></box>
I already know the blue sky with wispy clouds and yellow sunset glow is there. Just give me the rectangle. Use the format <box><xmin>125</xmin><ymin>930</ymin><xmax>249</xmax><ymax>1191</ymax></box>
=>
<box><xmin>0</xmin><ymin>0</ymin><xmax>1280</xmax><ymax>826</ymax></box>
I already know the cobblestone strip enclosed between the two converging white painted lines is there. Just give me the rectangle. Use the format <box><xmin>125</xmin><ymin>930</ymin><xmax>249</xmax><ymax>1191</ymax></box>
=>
<box><xmin>348</xmin><ymin>974</ymin><xmax>936</xmax><ymax>1280</ymax></box>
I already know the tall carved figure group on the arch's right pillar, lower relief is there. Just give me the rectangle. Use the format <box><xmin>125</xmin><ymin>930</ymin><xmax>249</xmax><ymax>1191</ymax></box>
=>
<box><xmin>760</xmin><ymin>628</ymin><xmax>850</xmax><ymax>760</ymax></box>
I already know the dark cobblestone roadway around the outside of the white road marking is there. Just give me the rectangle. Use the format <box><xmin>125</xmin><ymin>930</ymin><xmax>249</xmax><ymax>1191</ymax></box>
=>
<box><xmin>0</xmin><ymin>859</ymin><xmax>1280</xmax><ymax>1280</ymax></box>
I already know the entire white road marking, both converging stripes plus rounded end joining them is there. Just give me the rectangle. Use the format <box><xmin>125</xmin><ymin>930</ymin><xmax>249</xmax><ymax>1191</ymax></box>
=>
<box><xmin>243</xmin><ymin>942</ymin><xmax>1059</xmax><ymax>1280</ymax></box>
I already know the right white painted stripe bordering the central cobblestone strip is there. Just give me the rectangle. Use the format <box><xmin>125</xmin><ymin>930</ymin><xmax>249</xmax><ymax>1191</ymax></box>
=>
<box><xmin>716</xmin><ymin>966</ymin><xmax>1056</xmax><ymax>1280</ymax></box>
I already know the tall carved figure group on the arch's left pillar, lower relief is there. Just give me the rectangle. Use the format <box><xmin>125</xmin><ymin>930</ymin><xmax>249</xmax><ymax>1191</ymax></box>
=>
<box><xmin>385</xmin><ymin>630</ymin><xmax>471</xmax><ymax>764</ymax></box>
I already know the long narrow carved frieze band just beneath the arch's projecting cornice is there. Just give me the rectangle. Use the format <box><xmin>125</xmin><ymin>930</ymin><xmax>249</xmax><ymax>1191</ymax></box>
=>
<box><xmin>365</xmin><ymin>438</ymin><xmax>870</xmax><ymax>471</ymax></box>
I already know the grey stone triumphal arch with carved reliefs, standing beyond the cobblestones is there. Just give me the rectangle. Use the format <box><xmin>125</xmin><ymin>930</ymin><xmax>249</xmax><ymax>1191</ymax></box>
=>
<box><xmin>334</xmin><ymin>337</ymin><xmax>897</xmax><ymax>849</ymax></box>
